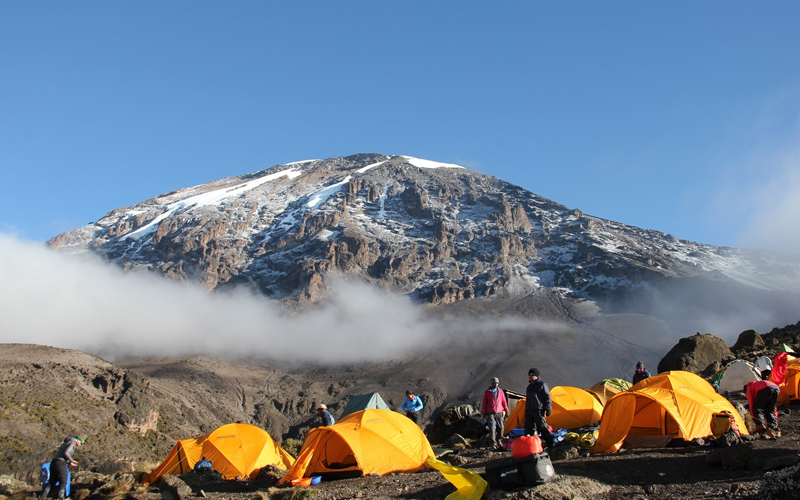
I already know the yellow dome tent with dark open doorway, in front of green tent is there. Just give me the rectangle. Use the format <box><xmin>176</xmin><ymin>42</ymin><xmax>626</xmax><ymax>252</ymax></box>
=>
<box><xmin>280</xmin><ymin>409</ymin><xmax>434</xmax><ymax>482</ymax></box>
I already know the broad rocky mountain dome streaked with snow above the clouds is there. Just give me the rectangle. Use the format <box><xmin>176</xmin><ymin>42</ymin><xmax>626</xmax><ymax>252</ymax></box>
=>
<box><xmin>49</xmin><ymin>154</ymin><xmax>800</xmax><ymax>332</ymax></box>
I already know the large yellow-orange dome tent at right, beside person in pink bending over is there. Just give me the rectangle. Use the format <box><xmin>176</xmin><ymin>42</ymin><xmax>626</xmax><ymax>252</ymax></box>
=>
<box><xmin>592</xmin><ymin>371</ymin><xmax>747</xmax><ymax>453</ymax></box>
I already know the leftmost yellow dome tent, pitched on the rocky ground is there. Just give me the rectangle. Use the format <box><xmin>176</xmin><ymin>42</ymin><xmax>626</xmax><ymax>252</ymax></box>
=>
<box><xmin>143</xmin><ymin>424</ymin><xmax>294</xmax><ymax>484</ymax></box>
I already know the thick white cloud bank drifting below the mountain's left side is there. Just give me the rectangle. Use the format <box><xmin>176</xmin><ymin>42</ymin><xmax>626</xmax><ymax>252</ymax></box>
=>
<box><xmin>0</xmin><ymin>234</ymin><xmax>446</xmax><ymax>362</ymax></box>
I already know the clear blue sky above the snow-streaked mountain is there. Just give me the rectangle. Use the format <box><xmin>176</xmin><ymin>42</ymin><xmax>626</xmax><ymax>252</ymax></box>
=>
<box><xmin>0</xmin><ymin>0</ymin><xmax>800</xmax><ymax>252</ymax></box>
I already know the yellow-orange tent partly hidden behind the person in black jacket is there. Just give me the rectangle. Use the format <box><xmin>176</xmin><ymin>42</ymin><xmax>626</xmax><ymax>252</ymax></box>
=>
<box><xmin>503</xmin><ymin>385</ymin><xmax>603</xmax><ymax>434</ymax></box>
